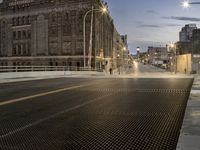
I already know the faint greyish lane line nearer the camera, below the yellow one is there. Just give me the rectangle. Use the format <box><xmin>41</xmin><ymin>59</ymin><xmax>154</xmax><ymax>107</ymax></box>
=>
<box><xmin>0</xmin><ymin>93</ymin><xmax>114</xmax><ymax>138</ymax></box>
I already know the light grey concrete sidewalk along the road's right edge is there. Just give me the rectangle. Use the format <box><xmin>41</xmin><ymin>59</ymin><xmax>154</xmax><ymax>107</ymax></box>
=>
<box><xmin>177</xmin><ymin>76</ymin><xmax>200</xmax><ymax>150</ymax></box>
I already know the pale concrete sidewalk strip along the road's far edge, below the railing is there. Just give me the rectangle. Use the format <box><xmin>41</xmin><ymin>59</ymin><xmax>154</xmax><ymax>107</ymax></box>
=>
<box><xmin>0</xmin><ymin>66</ymin><xmax>194</xmax><ymax>83</ymax></box>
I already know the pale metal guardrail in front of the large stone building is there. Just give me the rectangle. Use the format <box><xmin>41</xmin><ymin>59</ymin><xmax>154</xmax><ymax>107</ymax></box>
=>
<box><xmin>0</xmin><ymin>66</ymin><xmax>102</xmax><ymax>73</ymax></box>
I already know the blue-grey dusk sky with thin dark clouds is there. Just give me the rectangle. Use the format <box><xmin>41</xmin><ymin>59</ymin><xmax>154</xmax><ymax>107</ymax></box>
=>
<box><xmin>105</xmin><ymin>0</ymin><xmax>200</xmax><ymax>53</ymax></box>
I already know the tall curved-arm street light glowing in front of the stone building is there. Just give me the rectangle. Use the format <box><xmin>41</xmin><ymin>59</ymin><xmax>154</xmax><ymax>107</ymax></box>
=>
<box><xmin>83</xmin><ymin>6</ymin><xmax>108</xmax><ymax>68</ymax></box>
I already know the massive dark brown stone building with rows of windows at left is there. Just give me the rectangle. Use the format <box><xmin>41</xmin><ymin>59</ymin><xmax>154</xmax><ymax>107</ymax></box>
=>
<box><xmin>0</xmin><ymin>0</ymin><xmax>124</xmax><ymax>68</ymax></box>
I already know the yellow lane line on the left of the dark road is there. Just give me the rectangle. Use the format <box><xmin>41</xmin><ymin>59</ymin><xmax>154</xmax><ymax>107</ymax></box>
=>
<box><xmin>0</xmin><ymin>84</ymin><xmax>89</xmax><ymax>106</ymax></box>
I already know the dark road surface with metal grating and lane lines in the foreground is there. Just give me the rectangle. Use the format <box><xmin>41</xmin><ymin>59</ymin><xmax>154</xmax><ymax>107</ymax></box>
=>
<box><xmin>0</xmin><ymin>78</ymin><xmax>192</xmax><ymax>150</ymax></box>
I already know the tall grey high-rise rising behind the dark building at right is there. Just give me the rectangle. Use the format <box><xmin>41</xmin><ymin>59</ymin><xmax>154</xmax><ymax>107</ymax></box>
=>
<box><xmin>179</xmin><ymin>24</ymin><xmax>197</xmax><ymax>42</ymax></box>
